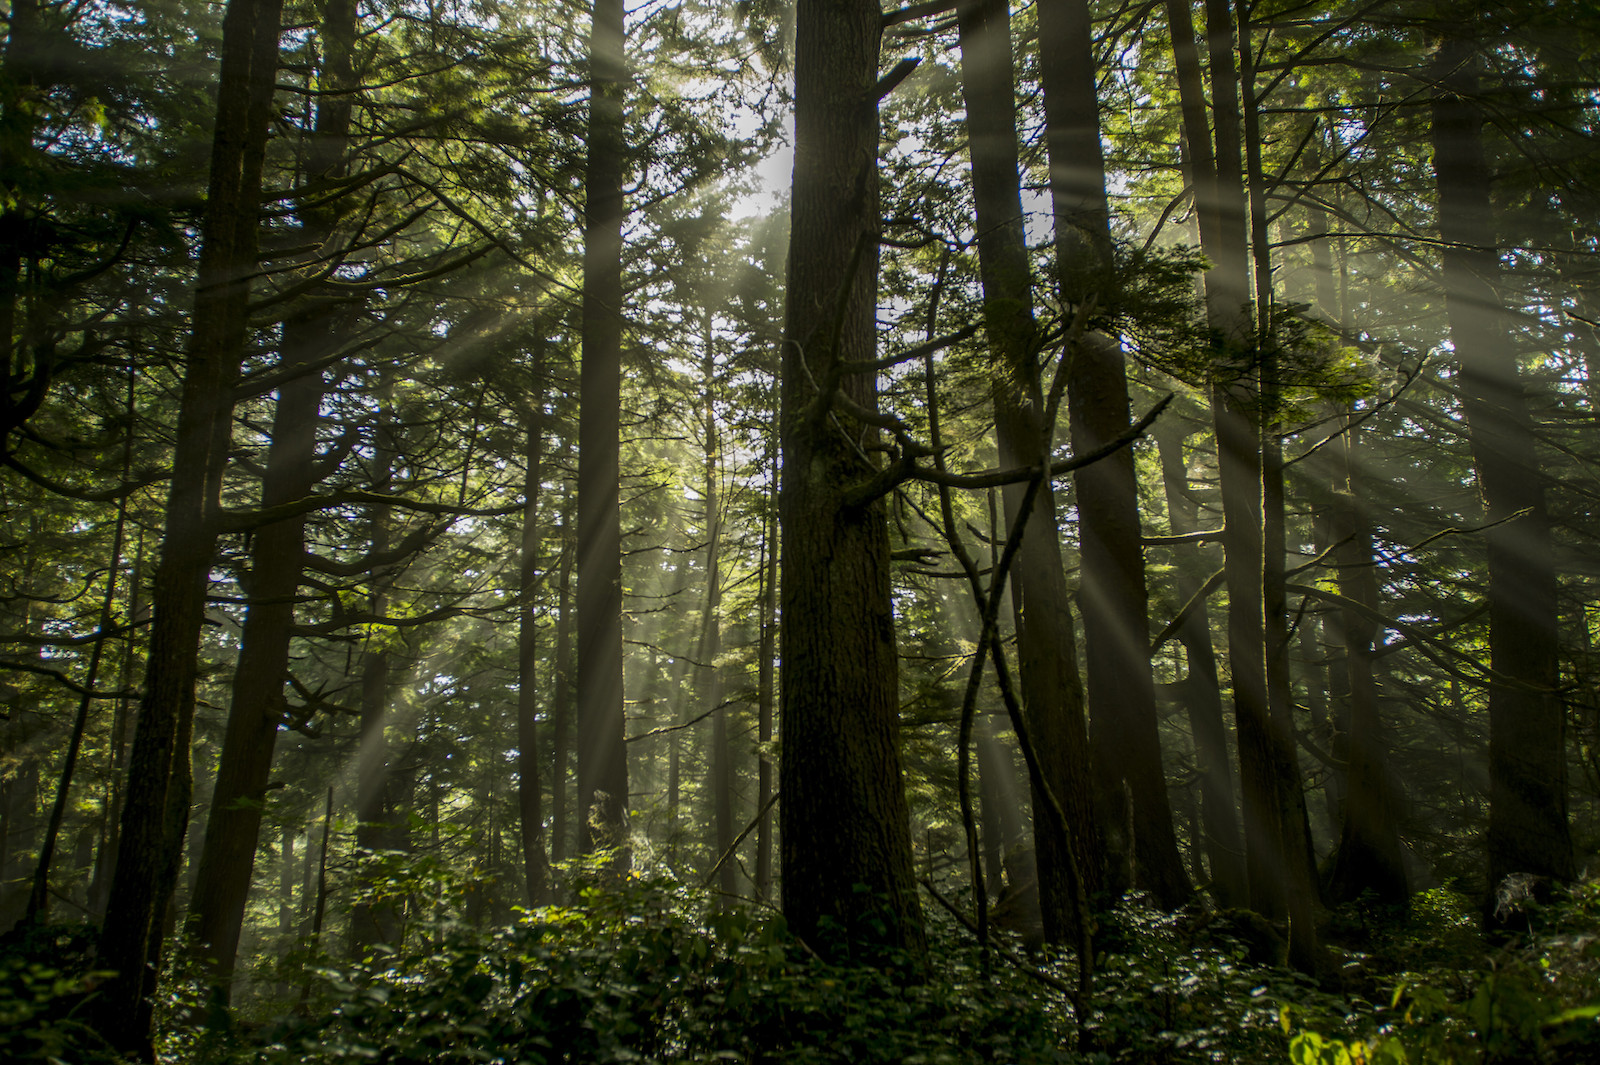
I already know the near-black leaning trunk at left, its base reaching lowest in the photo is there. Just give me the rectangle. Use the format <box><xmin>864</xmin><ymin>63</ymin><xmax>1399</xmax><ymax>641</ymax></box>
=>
<box><xmin>93</xmin><ymin>0</ymin><xmax>282</xmax><ymax>1060</ymax></box>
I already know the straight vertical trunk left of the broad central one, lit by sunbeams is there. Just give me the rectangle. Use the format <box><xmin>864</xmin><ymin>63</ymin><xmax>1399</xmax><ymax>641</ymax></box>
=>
<box><xmin>578</xmin><ymin>0</ymin><xmax>629</xmax><ymax>867</ymax></box>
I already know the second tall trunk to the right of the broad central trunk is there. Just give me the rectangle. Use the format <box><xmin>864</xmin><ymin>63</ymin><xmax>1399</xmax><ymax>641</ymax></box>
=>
<box><xmin>1038</xmin><ymin>0</ymin><xmax>1190</xmax><ymax>908</ymax></box>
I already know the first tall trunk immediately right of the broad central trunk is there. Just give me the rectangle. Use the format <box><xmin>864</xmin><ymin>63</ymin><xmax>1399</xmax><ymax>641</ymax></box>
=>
<box><xmin>957</xmin><ymin>0</ymin><xmax>1102</xmax><ymax>943</ymax></box>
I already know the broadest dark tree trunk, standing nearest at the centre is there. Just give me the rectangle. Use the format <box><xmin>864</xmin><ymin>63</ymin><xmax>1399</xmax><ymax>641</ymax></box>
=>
<box><xmin>779</xmin><ymin>0</ymin><xmax>925</xmax><ymax>958</ymax></box>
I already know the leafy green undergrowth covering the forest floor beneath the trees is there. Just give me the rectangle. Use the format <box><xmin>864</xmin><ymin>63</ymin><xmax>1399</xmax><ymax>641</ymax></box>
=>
<box><xmin>0</xmin><ymin>880</ymin><xmax>1600</xmax><ymax>1065</ymax></box>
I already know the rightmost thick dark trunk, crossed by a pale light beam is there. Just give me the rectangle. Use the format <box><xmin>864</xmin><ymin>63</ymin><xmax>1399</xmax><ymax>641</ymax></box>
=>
<box><xmin>1434</xmin><ymin>27</ymin><xmax>1574</xmax><ymax>892</ymax></box>
